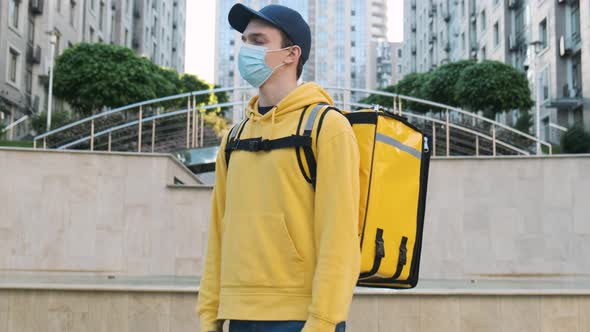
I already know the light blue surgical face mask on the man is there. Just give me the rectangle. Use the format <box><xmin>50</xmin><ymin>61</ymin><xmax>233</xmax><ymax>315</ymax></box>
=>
<box><xmin>238</xmin><ymin>44</ymin><xmax>288</xmax><ymax>88</ymax></box>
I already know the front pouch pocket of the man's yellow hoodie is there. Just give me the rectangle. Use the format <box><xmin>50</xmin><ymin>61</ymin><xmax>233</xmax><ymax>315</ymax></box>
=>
<box><xmin>221</xmin><ymin>214</ymin><xmax>304</xmax><ymax>288</ymax></box>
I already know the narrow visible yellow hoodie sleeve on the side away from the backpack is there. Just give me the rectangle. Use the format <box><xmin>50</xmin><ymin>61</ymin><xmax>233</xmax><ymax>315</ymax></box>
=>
<box><xmin>197</xmin><ymin>135</ymin><xmax>227</xmax><ymax>332</ymax></box>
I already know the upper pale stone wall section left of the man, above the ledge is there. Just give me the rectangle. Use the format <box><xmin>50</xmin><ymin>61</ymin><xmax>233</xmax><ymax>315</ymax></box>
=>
<box><xmin>0</xmin><ymin>149</ymin><xmax>210</xmax><ymax>275</ymax></box>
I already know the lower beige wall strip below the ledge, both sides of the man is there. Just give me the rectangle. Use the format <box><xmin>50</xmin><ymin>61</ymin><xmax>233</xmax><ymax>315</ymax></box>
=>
<box><xmin>0</xmin><ymin>290</ymin><xmax>590</xmax><ymax>332</ymax></box>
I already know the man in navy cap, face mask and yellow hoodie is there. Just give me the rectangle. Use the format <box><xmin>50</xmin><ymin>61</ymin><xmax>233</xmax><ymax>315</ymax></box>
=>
<box><xmin>198</xmin><ymin>4</ymin><xmax>360</xmax><ymax>332</ymax></box>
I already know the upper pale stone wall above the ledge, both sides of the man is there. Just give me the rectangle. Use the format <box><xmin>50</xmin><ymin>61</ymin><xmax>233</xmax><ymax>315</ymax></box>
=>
<box><xmin>0</xmin><ymin>149</ymin><xmax>590</xmax><ymax>279</ymax></box>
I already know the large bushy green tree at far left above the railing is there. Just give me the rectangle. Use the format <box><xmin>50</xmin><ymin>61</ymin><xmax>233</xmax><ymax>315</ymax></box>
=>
<box><xmin>54</xmin><ymin>43</ymin><xmax>174</xmax><ymax>116</ymax></box>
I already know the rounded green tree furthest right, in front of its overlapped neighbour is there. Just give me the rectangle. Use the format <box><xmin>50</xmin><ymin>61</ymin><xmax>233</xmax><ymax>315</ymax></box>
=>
<box><xmin>454</xmin><ymin>61</ymin><xmax>534</xmax><ymax>117</ymax></box>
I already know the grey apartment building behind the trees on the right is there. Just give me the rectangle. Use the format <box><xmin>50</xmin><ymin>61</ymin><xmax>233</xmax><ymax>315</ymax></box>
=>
<box><xmin>403</xmin><ymin>0</ymin><xmax>590</xmax><ymax>142</ymax></box>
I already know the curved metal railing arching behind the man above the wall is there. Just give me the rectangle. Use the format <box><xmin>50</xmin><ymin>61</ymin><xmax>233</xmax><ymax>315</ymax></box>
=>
<box><xmin>34</xmin><ymin>87</ymin><xmax>552</xmax><ymax>156</ymax></box>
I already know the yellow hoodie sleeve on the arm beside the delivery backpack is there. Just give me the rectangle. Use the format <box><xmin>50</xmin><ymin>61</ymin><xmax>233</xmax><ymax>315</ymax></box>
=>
<box><xmin>302</xmin><ymin>114</ymin><xmax>360</xmax><ymax>332</ymax></box>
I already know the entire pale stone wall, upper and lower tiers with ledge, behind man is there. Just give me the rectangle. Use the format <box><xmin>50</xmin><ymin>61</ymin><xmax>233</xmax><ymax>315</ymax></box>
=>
<box><xmin>0</xmin><ymin>148</ymin><xmax>590</xmax><ymax>332</ymax></box>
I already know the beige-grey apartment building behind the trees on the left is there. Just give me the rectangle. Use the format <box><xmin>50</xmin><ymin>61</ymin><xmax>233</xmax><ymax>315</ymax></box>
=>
<box><xmin>0</xmin><ymin>0</ymin><xmax>186</xmax><ymax>138</ymax></box>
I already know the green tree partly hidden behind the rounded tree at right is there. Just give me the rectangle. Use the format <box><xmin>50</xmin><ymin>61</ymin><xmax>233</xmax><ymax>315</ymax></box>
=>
<box><xmin>423</xmin><ymin>60</ymin><xmax>477</xmax><ymax>106</ymax></box>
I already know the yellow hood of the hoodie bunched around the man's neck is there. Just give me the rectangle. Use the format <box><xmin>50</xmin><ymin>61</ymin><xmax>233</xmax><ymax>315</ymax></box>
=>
<box><xmin>246</xmin><ymin>83</ymin><xmax>334</xmax><ymax>121</ymax></box>
